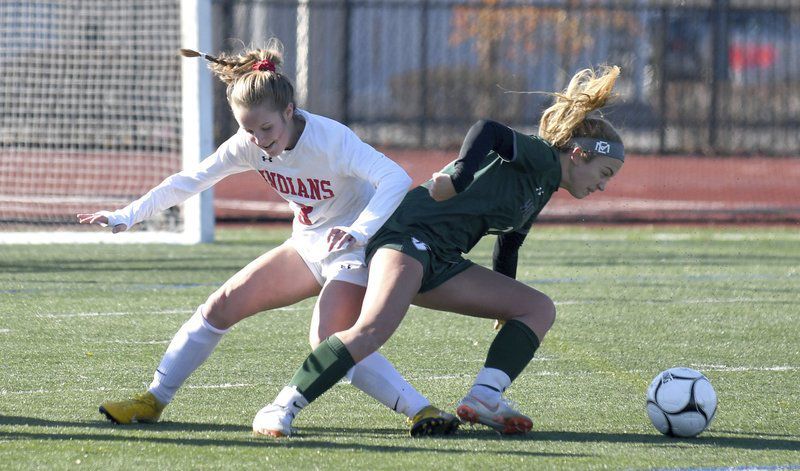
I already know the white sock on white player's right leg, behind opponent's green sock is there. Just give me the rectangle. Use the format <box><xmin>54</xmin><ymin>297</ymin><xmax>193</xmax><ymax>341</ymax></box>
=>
<box><xmin>347</xmin><ymin>352</ymin><xmax>430</xmax><ymax>417</ymax></box>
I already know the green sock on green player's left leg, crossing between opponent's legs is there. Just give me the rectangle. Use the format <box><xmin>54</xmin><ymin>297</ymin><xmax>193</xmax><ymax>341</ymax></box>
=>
<box><xmin>289</xmin><ymin>335</ymin><xmax>356</xmax><ymax>403</ymax></box>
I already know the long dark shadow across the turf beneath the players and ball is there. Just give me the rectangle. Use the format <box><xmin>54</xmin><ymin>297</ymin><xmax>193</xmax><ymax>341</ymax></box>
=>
<box><xmin>0</xmin><ymin>415</ymin><xmax>800</xmax><ymax>457</ymax></box>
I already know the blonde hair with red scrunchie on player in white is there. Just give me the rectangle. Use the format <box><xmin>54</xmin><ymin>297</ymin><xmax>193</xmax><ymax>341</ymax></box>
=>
<box><xmin>181</xmin><ymin>38</ymin><xmax>294</xmax><ymax>111</ymax></box>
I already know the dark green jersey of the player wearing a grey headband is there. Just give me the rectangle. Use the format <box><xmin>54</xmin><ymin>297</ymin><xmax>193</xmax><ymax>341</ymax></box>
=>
<box><xmin>384</xmin><ymin>131</ymin><xmax>561</xmax><ymax>259</ymax></box>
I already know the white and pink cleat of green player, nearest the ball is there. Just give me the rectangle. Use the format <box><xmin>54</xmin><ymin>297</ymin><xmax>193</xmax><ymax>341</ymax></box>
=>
<box><xmin>456</xmin><ymin>394</ymin><xmax>533</xmax><ymax>434</ymax></box>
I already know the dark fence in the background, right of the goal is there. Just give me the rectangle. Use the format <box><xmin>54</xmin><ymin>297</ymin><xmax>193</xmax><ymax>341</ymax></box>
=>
<box><xmin>213</xmin><ymin>0</ymin><xmax>800</xmax><ymax>155</ymax></box>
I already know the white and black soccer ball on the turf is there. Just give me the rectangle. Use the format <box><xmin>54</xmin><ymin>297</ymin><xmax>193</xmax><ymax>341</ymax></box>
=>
<box><xmin>647</xmin><ymin>368</ymin><xmax>717</xmax><ymax>437</ymax></box>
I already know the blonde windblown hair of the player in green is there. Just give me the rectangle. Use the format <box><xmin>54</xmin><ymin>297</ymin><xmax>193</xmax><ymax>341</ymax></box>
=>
<box><xmin>539</xmin><ymin>66</ymin><xmax>622</xmax><ymax>149</ymax></box>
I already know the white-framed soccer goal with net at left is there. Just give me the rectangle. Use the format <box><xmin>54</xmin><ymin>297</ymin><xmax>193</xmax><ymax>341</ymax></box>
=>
<box><xmin>0</xmin><ymin>0</ymin><xmax>214</xmax><ymax>244</ymax></box>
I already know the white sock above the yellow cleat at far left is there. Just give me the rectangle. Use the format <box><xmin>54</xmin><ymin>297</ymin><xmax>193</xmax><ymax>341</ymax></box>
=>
<box><xmin>148</xmin><ymin>304</ymin><xmax>229</xmax><ymax>404</ymax></box>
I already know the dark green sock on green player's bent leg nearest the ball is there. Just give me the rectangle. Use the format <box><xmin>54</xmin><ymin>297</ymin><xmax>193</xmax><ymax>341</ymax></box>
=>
<box><xmin>483</xmin><ymin>319</ymin><xmax>539</xmax><ymax>381</ymax></box>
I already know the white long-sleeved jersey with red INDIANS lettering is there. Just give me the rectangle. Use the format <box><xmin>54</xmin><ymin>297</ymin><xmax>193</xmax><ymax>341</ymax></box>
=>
<box><xmin>108</xmin><ymin>110</ymin><xmax>411</xmax><ymax>260</ymax></box>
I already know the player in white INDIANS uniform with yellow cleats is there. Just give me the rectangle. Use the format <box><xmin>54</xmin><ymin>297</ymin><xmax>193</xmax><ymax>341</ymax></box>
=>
<box><xmin>78</xmin><ymin>39</ymin><xmax>458</xmax><ymax>436</ymax></box>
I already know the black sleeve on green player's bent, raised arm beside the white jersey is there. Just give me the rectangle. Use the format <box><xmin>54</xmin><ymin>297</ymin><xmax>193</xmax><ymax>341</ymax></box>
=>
<box><xmin>450</xmin><ymin>120</ymin><xmax>514</xmax><ymax>193</ymax></box>
